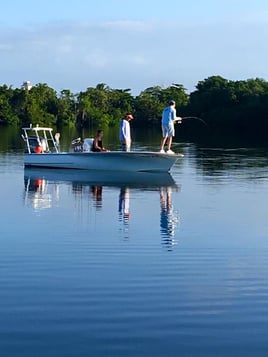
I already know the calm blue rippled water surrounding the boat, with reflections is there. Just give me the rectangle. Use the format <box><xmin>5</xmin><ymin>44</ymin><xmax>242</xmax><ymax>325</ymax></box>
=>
<box><xmin>0</xmin><ymin>129</ymin><xmax>268</xmax><ymax>357</ymax></box>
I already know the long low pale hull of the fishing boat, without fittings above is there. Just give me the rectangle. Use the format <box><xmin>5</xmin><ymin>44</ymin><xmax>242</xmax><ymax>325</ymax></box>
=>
<box><xmin>24</xmin><ymin>151</ymin><xmax>183</xmax><ymax>172</ymax></box>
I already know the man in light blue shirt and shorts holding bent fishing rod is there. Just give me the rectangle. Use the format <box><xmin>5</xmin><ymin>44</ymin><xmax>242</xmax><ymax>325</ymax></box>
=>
<box><xmin>160</xmin><ymin>100</ymin><xmax>181</xmax><ymax>154</ymax></box>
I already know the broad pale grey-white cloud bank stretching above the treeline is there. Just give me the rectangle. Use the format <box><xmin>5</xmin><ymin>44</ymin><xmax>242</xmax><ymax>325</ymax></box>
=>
<box><xmin>0</xmin><ymin>18</ymin><xmax>268</xmax><ymax>93</ymax></box>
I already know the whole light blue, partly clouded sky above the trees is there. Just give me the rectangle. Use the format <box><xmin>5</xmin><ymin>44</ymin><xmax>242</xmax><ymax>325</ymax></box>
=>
<box><xmin>0</xmin><ymin>0</ymin><xmax>268</xmax><ymax>95</ymax></box>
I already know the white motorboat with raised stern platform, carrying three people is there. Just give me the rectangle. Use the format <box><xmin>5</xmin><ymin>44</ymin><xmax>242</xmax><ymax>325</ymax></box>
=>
<box><xmin>22</xmin><ymin>125</ymin><xmax>183</xmax><ymax>172</ymax></box>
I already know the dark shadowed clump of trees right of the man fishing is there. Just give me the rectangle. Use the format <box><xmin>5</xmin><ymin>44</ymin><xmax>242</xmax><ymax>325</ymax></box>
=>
<box><xmin>188</xmin><ymin>76</ymin><xmax>268</xmax><ymax>136</ymax></box>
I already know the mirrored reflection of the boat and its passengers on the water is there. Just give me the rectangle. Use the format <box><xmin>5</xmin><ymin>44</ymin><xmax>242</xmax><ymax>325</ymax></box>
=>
<box><xmin>24</xmin><ymin>168</ymin><xmax>179</xmax><ymax>248</ymax></box>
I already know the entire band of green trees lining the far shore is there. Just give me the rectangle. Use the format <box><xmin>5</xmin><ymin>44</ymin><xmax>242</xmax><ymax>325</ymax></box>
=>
<box><xmin>0</xmin><ymin>76</ymin><xmax>268</xmax><ymax>142</ymax></box>
